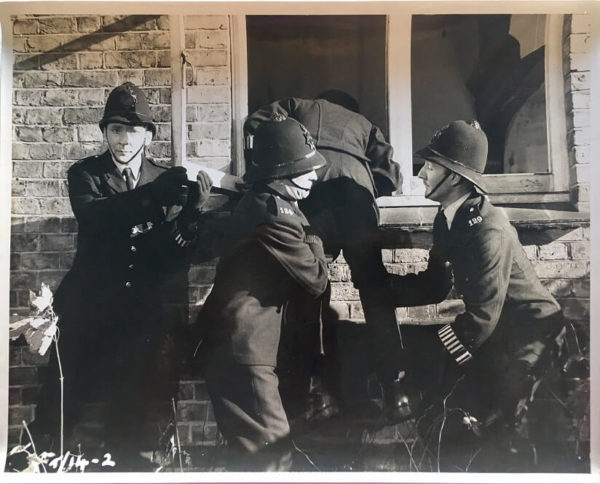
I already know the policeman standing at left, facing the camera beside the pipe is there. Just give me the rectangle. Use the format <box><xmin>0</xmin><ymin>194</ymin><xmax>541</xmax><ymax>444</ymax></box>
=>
<box><xmin>33</xmin><ymin>82</ymin><xmax>211</xmax><ymax>470</ymax></box>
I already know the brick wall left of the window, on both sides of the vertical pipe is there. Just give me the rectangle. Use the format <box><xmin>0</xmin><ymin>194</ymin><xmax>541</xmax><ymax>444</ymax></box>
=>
<box><xmin>9</xmin><ymin>15</ymin><xmax>231</xmax><ymax>454</ymax></box>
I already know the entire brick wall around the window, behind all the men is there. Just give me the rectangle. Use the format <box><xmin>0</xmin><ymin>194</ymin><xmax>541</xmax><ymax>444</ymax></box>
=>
<box><xmin>9</xmin><ymin>12</ymin><xmax>590</xmax><ymax>470</ymax></box>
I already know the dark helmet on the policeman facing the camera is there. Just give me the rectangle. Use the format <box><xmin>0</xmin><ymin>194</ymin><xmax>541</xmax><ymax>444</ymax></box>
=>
<box><xmin>100</xmin><ymin>82</ymin><xmax>156</xmax><ymax>135</ymax></box>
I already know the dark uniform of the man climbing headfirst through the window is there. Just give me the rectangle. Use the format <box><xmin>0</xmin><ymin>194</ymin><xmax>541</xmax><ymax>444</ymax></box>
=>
<box><xmin>244</xmin><ymin>98</ymin><xmax>420</xmax><ymax>398</ymax></box>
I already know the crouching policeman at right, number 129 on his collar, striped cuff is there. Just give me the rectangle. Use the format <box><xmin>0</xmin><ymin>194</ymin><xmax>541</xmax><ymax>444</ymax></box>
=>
<box><xmin>394</xmin><ymin>120</ymin><xmax>564</xmax><ymax>471</ymax></box>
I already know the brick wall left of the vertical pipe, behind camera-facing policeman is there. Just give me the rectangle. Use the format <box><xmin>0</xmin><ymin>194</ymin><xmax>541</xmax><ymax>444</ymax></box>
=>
<box><xmin>11</xmin><ymin>16</ymin><xmax>171</xmax><ymax>310</ymax></box>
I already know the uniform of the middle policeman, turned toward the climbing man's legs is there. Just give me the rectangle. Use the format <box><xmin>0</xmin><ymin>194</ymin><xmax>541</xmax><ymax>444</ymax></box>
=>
<box><xmin>197</xmin><ymin>184</ymin><xmax>328</xmax><ymax>466</ymax></box>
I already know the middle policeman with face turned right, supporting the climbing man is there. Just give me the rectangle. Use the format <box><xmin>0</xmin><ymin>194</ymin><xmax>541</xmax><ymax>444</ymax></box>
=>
<box><xmin>196</xmin><ymin>116</ymin><xmax>328</xmax><ymax>470</ymax></box>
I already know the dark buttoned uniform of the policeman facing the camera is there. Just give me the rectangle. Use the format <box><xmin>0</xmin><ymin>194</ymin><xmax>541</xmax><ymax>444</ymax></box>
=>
<box><xmin>35</xmin><ymin>152</ymin><xmax>195</xmax><ymax>464</ymax></box>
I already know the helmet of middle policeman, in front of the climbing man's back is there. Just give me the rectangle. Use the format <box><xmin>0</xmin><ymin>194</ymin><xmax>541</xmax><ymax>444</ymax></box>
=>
<box><xmin>246</xmin><ymin>114</ymin><xmax>326</xmax><ymax>182</ymax></box>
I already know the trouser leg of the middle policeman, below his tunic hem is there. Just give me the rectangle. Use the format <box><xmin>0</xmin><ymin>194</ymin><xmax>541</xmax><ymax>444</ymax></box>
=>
<box><xmin>205</xmin><ymin>365</ymin><xmax>291</xmax><ymax>471</ymax></box>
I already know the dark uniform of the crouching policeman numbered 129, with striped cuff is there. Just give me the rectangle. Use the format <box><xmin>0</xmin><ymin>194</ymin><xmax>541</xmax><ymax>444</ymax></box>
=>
<box><xmin>402</xmin><ymin>193</ymin><xmax>564</xmax><ymax>428</ymax></box>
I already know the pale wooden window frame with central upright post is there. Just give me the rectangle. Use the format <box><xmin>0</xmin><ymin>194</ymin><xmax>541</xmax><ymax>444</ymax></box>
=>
<box><xmin>231</xmin><ymin>9</ymin><xmax>570</xmax><ymax>207</ymax></box>
